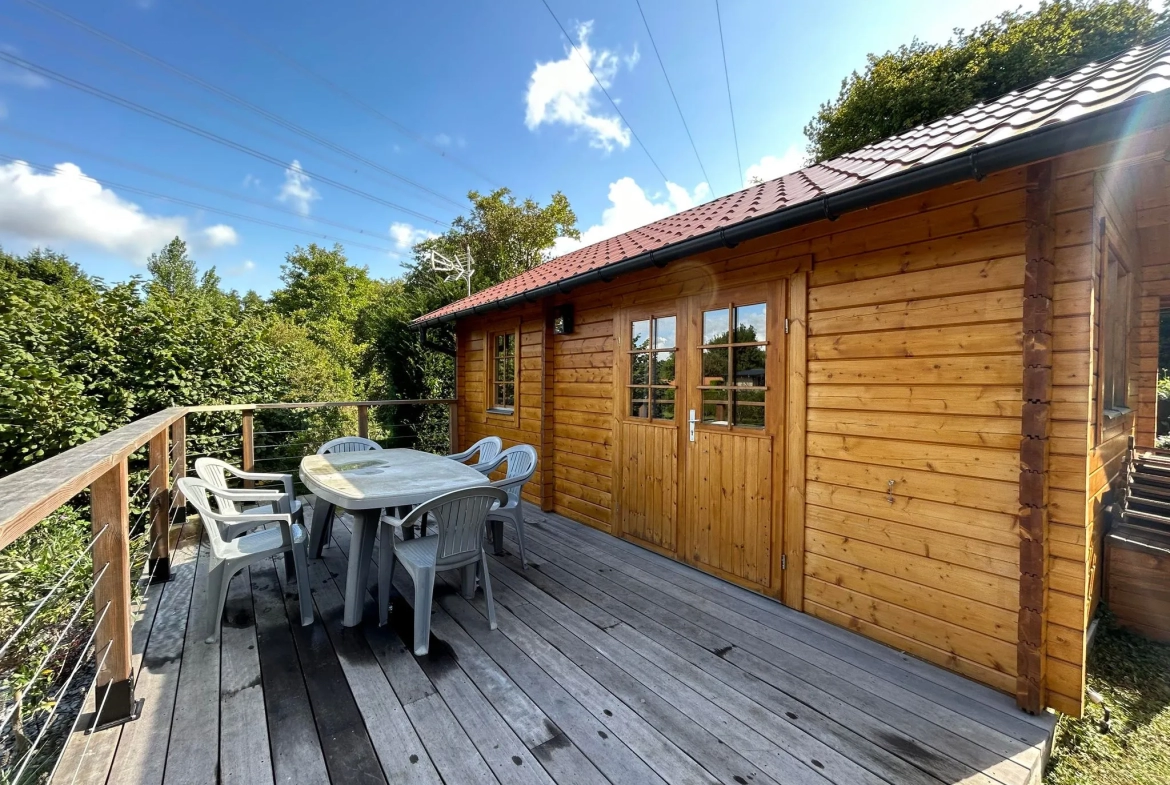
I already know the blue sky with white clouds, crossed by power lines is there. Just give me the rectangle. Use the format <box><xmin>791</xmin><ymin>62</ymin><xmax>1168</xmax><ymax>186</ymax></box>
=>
<box><xmin>0</xmin><ymin>0</ymin><xmax>1034</xmax><ymax>294</ymax></box>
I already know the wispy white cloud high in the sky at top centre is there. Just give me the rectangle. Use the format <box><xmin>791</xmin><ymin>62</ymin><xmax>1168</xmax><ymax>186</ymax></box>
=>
<box><xmin>524</xmin><ymin>21</ymin><xmax>639</xmax><ymax>152</ymax></box>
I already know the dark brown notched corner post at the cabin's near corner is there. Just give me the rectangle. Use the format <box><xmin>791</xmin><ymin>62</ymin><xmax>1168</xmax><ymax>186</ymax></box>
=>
<box><xmin>1016</xmin><ymin>161</ymin><xmax>1055</xmax><ymax>714</ymax></box>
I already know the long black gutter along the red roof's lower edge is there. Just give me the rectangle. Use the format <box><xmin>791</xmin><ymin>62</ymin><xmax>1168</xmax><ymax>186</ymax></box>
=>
<box><xmin>413</xmin><ymin>90</ymin><xmax>1170</xmax><ymax>329</ymax></box>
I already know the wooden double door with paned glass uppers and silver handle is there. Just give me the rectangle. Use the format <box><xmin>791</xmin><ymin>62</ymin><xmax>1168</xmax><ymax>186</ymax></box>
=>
<box><xmin>614</xmin><ymin>281</ymin><xmax>785</xmax><ymax>597</ymax></box>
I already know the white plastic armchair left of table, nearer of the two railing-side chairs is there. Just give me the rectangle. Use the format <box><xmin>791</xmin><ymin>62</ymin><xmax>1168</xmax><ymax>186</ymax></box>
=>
<box><xmin>176</xmin><ymin>477</ymin><xmax>312</xmax><ymax>643</ymax></box>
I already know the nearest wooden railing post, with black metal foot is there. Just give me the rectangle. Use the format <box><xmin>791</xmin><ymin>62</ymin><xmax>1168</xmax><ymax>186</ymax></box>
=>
<box><xmin>90</xmin><ymin>457</ymin><xmax>142</xmax><ymax>729</ymax></box>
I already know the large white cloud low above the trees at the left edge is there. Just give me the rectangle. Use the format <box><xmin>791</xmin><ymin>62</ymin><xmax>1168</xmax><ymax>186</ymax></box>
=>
<box><xmin>0</xmin><ymin>161</ymin><xmax>191</xmax><ymax>263</ymax></box>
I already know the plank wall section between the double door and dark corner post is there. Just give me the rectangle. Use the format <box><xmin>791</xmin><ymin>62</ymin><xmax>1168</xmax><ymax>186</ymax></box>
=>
<box><xmin>805</xmin><ymin>171</ymin><xmax>1024</xmax><ymax>691</ymax></box>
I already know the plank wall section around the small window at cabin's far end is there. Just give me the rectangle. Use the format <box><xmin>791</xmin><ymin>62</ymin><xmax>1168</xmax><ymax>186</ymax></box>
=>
<box><xmin>456</xmin><ymin>304</ymin><xmax>544</xmax><ymax>507</ymax></box>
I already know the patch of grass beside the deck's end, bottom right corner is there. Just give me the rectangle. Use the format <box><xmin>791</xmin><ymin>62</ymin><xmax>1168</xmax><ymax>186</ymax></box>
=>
<box><xmin>1044</xmin><ymin>611</ymin><xmax>1170</xmax><ymax>785</ymax></box>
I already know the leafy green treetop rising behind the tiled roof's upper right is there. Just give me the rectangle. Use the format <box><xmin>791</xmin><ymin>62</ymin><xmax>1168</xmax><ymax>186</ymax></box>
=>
<box><xmin>805</xmin><ymin>0</ymin><xmax>1170</xmax><ymax>161</ymax></box>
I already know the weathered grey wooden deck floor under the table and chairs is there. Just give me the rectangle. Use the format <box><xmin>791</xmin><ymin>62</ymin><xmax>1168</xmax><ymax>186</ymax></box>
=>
<box><xmin>55</xmin><ymin>509</ymin><xmax>1054</xmax><ymax>785</ymax></box>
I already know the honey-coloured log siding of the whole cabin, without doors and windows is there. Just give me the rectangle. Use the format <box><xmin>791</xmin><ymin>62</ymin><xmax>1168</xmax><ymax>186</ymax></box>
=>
<box><xmin>446</xmin><ymin>129</ymin><xmax>1170</xmax><ymax>715</ymax></box>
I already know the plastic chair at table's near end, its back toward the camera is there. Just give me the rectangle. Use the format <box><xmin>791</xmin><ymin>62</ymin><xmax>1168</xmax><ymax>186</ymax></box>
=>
<box><xmin>378</xmin><ymin>487</ymin><xmax>508</xmax><ymax>656</ymax></box>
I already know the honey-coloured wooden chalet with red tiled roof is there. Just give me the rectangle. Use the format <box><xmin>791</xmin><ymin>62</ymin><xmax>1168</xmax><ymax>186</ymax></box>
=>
<box><xmin>417</xmin><ymin>41</ymin><xmax>1170</xmax><ymax>715</ymax></box>
